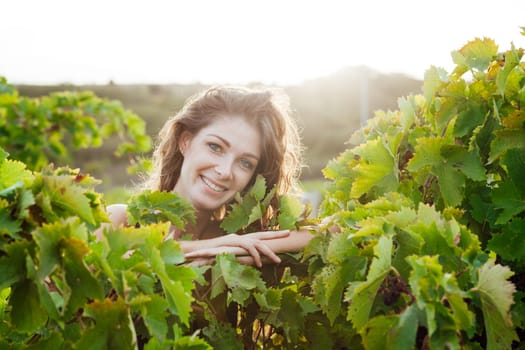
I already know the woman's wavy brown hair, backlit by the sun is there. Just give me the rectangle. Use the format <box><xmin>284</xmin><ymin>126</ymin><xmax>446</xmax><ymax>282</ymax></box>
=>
<box><xmin>145</xmin><ymin>86</ymin><xmax>302</xmax><ymax>219</ymax></box>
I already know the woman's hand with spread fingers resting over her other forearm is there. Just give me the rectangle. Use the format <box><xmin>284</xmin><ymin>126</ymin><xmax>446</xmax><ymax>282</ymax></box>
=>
<box><xmin>185</xmin><ymin>230</ymin><xmax>290</xmax><ymax>267</ymax></box>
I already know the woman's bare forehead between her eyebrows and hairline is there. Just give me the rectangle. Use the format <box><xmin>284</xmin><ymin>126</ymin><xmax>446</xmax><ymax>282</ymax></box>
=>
<box><xmin>198</xmin><ymin>114</ymin><xmax>262</xmax><ymax>157</ymax></box>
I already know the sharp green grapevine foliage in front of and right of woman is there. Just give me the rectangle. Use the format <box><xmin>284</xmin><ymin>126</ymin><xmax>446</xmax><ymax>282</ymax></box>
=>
<box><xmin>0</xmin><ymin>29</ymin><xmax>525</xmax><ymax>350</ymax></box>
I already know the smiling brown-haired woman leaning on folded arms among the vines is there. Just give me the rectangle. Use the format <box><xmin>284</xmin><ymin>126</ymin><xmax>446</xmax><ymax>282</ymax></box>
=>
<box><xmin>101</xmin><ymin>86</ymin><xmax>311</xmax><ymax>267</ymax></box>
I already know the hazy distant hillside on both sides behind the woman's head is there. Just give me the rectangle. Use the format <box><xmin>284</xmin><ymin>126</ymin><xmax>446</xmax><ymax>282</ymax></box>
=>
<box><xmin>15</xmin><ymin>66</ymin><xmax>422</xmax><ymax>190</ymax></box>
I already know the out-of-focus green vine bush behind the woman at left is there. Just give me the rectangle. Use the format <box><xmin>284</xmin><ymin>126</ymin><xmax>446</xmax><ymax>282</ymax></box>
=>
<box><xmin>0</xmin><ymin>76</ymin><xmax>151</xmax><ymax>171</ymax></box>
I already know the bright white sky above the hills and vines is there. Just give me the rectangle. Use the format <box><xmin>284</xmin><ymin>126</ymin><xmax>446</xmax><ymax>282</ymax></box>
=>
<box><xmin>0</xmin><ymin>0</ymin><xmax>525</xmax><ymax>84</ymax></box>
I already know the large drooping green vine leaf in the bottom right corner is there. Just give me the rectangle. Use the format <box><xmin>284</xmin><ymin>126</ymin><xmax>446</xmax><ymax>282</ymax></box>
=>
<box><xmin>474</xmin><ymin>260</ymin><xmax>518</xmax><ymax>350</ymax></box>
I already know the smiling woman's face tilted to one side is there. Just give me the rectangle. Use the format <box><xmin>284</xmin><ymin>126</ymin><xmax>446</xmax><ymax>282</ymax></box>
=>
<box><xmin>174</xmin><ymin>115</ymin><xmax>261</xmax><ymax>211</ymax></box>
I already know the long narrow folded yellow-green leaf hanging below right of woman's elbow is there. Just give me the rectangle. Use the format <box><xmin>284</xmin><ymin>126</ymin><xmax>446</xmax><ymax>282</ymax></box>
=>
<box><xmin>345</xmin><ymin>236</ymin><xmax>392</xmax><ymax>330</ymax></box>
